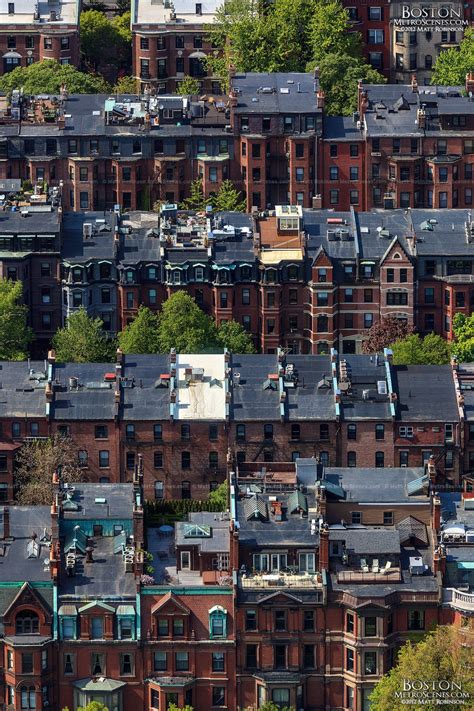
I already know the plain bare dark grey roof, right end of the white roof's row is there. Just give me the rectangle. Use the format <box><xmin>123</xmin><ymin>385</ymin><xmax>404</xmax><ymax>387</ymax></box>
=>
<box><xmin>392</xmin><ymin>365</ymin><xmax>459</xmax><ymax>422</ymax></box>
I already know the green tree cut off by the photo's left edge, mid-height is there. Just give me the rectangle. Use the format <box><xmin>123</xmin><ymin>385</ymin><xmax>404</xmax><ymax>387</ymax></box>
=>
<box><xmin>0</xmin><ymin>279</ymin><xmax>33</xmax><ymax>360</ymax></box>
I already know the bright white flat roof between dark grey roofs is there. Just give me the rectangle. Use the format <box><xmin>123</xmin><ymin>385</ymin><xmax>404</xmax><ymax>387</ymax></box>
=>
<box><xmin>176</xmin><ymin>354</ymin><xmax>225</xmax><ymax>420</ymax></box>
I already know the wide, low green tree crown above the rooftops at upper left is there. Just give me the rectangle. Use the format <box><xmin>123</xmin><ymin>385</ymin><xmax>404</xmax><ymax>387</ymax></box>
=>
<box><xmin>0</xmin><ymin>59</ymin><xmax>109</xmax><ymax>94</ymax></box>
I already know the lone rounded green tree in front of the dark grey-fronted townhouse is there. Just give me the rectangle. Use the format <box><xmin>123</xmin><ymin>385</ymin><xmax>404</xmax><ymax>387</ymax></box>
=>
<box><xmin>53</xmin><ymin>308</ymin><xmax>115</xmax><ymax>363</ymax></box>
